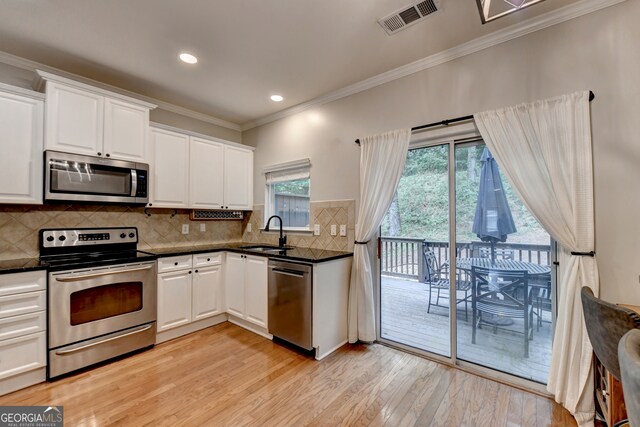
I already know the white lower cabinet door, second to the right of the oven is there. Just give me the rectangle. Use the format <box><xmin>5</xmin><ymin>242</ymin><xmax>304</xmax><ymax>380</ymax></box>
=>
<box><xmin>191</xmin><ymin>265</ymin><xmax>222</xmax><ymax>321</ymax></box>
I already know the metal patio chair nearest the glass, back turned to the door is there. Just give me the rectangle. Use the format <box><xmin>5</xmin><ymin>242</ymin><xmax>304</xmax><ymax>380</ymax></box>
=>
<box><xmin>471</xmin><ymin>266</ymin><xmax>533</xmax><ymax>358</ymax></box>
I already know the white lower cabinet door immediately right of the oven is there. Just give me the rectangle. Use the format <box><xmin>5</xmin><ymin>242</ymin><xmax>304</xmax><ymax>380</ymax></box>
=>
<box><xmin>158</xmin><ymin>270</ymin><xmax>192</xmax><ymax>332</ymax></box>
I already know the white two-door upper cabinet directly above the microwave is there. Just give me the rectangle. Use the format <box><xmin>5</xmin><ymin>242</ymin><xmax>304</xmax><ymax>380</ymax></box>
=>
<box><xmin>36</xmin><ymin>71</ymin><xmax>156</xmax><ymax>162</ymax></box>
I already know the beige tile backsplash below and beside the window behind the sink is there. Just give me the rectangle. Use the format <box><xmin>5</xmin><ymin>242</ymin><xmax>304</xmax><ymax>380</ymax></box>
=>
<box><xmin>242</xmin><ymin>200</ymin><xmax>356</xmax><ymax>251</ymax></box>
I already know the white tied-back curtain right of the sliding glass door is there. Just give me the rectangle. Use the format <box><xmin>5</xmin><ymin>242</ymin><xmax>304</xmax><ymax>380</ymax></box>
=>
<box><xmin>474</xmin><ymin>92</ymin><xmax>599</xmax><ymax>425</ymax></box>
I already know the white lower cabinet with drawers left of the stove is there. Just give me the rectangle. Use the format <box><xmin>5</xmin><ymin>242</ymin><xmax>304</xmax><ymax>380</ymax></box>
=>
<box><xmin>0</xmin><ymin>271</ymin><xmax>47</xmax><ymax>395</ymax></box>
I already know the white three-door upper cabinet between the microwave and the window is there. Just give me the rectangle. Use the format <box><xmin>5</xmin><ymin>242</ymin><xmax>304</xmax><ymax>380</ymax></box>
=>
<box><xmin>149</xmin><ymin>123</ymin><xmax>253</xmax><ymax>210</ymax></box>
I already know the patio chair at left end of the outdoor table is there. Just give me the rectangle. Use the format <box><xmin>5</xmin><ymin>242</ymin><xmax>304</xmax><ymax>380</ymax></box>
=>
<box><xmin>422</xmin><ymin>242</ymin><xmax>471</xmax><ymax>322</ymax></box>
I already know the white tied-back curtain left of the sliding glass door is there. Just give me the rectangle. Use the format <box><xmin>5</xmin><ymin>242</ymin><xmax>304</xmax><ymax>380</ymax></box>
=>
<box><xmin>349</xmin><ymin>129</ymin><xmax>411</xmax><ymax>343</ymax></box>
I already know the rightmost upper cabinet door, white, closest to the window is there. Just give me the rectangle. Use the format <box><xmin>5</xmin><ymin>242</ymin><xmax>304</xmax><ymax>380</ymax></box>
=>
<box><xmin>224</xmin><ymin>146</ymin><xmax>253</xmax><ymax>209</ymax></box>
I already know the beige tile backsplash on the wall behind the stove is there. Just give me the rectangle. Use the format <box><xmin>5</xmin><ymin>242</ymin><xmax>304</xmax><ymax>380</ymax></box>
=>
<box><xmin>0</xmin><ymin>204</ymin><xmax>242</xmax><ymax>260</ymax></box>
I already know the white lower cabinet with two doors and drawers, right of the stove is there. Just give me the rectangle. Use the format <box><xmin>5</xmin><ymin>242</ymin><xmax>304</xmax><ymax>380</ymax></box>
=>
<box><xmin>157</xmin><ymin>253</ymin><xmax>224</xmax><ymax>333</ymax></box>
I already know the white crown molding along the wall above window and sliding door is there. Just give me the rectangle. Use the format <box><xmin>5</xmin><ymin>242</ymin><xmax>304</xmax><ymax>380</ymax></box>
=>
<box><xmin>242</xmin><ymin>0</ymin><xmax>626</xmax><ymax>131</ymax></box>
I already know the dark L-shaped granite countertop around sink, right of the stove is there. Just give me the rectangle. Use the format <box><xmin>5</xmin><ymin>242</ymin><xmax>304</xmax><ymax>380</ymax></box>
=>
<box><xmin>144</xmin><ymin>242</ymin><xmax>353</xmax><ymax>263</ymax></box>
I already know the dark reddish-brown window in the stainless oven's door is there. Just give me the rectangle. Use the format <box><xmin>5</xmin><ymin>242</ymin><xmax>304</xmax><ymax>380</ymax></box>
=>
<box><xmin>71</xmin><ymin>282</ymin><xmax>142</xmax><ymax>325</ymax></box>
